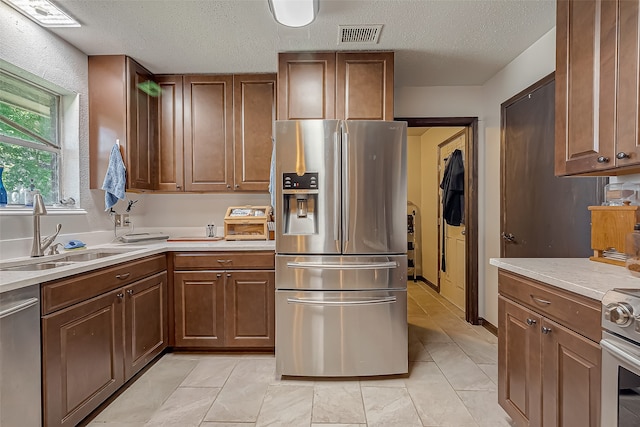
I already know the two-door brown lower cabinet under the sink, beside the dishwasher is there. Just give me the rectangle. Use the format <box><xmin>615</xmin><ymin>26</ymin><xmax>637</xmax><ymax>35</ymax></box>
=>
<box><xmin>42</xmin><ymin>255</ymin><xmax>168</xmax><ymax>427</ymax></box>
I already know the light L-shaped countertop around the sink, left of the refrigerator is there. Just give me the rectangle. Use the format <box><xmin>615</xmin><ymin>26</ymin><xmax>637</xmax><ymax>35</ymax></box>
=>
<box><xmin>0</xmin><ymin>240</ymin><xmax>275</xmax><ymax>293</ymax></box>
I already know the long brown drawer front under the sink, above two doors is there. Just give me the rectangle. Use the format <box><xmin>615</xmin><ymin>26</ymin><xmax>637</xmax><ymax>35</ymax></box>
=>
<box><xmin>41</xmin><ymin>254</ymin><xmax>167</xmax><ymax>315</ymax></box>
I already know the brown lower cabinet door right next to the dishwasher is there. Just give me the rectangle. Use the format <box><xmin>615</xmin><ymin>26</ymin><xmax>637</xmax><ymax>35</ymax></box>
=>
<box><xmin>42</xmin><ymin>290</ymin><xmax>124</xmax><ymax>427</ymax></box>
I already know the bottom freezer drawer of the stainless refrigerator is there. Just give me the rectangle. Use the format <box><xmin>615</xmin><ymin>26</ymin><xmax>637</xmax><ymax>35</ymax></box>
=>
<box><xmin>276</xmin><ymin>290</ymin><xmax>408</xmax><ymax>377</ymax></box>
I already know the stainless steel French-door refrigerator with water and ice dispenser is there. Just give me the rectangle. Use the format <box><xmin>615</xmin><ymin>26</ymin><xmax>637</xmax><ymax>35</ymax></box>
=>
<box><xmin>275</xmin><ymin>120</ymin><xmax>408</xmax><ymax>377</ymax></box>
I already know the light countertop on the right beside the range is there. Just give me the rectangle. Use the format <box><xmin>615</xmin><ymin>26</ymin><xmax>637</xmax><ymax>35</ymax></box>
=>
<box><xmin>489</xmin><ymin>258</ymin><xmax>640</xmax><ymax>301</ymax></box>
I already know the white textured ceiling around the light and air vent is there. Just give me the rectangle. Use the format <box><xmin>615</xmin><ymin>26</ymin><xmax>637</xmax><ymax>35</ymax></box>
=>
<box><xmin>43</xmin><ymin>0</ymin><xmax>555</xmax><ymax>86</ymax></box>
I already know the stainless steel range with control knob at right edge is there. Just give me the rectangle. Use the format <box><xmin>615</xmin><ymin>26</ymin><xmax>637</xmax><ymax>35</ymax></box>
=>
<box><xmin>600</xmin><ymin>289</ymin><xmax>640</xmax><ymax>427</ymax></box>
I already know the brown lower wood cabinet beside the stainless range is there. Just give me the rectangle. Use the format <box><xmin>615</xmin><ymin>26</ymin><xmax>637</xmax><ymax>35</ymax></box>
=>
<box><xmin>498</xmin><ymin>271</ymin><xmax>601</xmax><ymax>427</ymax></box>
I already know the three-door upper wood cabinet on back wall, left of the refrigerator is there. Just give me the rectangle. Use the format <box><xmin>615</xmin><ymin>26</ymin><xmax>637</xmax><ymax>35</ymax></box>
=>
<box><xmin>156</xmin><ymin>74</ymin><xmax>276</xmax><ymax>192</ymax></box>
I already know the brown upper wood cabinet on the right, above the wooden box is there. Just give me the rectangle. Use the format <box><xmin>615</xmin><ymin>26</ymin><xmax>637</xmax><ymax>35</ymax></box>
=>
<box><xmin>555</xmin><ymin>0</ymin><xmax>640</xmax><ymax>175</ymax></box>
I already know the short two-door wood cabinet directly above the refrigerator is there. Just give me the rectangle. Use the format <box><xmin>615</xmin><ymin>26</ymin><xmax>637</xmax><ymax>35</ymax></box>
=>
<box><xmin>278</xmin><ymin>52</ymin><xmax>394</xmax><ymax>120</ymax></box>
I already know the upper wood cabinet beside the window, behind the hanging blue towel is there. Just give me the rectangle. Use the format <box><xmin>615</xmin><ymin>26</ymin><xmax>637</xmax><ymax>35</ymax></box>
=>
<box><xmin>88</xmin><ymin>55</ymin><xmax>157</xmax><ymax>190</ymax></box>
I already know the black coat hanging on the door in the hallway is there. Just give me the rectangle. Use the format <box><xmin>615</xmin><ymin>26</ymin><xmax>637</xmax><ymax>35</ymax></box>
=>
<box><xmin>440</xmin><ymin>150</ymin><xmax>464</xmax><ymax>226</ymax></box>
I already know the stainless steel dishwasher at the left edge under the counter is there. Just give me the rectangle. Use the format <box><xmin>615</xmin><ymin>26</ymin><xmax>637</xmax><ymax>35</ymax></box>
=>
<box><xmin>0</xmin><ymin>285</ymin><xmax>42</xmax><ymax>427</ymax></box>
